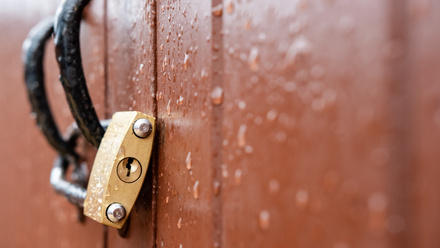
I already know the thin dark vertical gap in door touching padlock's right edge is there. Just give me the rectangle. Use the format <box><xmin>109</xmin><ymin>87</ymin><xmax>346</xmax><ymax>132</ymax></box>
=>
<box><xmin>150</xmin><ymin>0</ymin><xmax>161</xmax><ymax>247</ymax></box>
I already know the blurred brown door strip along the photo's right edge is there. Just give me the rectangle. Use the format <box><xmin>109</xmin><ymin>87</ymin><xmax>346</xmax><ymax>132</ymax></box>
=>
<box><xmin>404</xmin><ymin>1</ymin><xmax>440</xmax><ymax>247</ymax></box>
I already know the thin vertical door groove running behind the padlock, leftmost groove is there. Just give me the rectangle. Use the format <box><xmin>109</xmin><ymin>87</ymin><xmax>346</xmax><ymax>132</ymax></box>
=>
<box><xmin>103</xmin><ymin>0</ymin><xmax>110</xmax><ymax>248</ymax></box>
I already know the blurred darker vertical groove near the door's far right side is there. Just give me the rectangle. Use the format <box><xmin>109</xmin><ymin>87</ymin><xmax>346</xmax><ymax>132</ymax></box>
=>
<box><xmin>385</xmin><ymin>0</ymin><xmax>413</xmax><ymax>248</ymax></box>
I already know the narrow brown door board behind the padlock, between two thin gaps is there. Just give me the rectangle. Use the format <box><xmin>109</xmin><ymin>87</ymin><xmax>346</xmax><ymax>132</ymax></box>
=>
<box><xmin>106</xmin><ymin>0</ymin><xmax>157</xmax><ymax>247</ymax></box>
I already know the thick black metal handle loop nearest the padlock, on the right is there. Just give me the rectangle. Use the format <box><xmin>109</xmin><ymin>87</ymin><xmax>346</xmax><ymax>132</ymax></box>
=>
<box><xmin>54</xmin><ymin>0</ymin><xmax>104</xmax><ymax>148</ymax></box>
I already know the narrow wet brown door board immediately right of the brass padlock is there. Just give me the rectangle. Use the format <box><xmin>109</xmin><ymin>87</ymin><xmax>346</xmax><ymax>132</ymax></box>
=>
<box><xmin>156</xmin><ymin>1</ymin><xmax>217</xmax><ymax>247</ymax></box>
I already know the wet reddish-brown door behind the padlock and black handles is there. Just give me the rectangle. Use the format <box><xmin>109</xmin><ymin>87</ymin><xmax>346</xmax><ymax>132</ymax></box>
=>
<box><xmin>0</xmin><ymin>0</ymin><xmax>440</xmax><ymax>248</ymax></box>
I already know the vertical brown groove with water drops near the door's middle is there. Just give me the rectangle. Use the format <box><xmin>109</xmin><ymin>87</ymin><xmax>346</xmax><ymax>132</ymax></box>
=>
<box><xmin>211</xmin><ymin>0</ymin><xmax>223</xmax><ymax>247</ymax></box>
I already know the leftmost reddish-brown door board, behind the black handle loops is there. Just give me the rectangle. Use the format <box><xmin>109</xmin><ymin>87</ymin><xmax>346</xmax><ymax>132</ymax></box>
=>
<box><xmin>0</xmin><ymin>1</ymin><xmax>104</xmax><ymax>247</ymax></box>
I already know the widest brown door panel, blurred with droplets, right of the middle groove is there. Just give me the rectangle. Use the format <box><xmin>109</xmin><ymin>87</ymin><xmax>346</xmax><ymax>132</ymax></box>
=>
<box><xmin>222</xmin><ymin>0</ymin><xmax>393</xmax><ymax>247</ymax></box>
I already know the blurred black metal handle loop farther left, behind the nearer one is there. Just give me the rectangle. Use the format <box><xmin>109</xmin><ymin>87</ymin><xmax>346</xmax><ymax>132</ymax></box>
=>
<box><xmin>23</xmin><ymin>17</ymin><xmax>78</xmax><ymax>159</ymax></box>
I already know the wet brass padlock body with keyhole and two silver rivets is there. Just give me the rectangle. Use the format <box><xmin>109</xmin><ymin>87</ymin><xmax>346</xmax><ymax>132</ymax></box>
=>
<box><xmin>84</xmin><ymin>111</ymin><xmax>156</xmax><ymax>229</ymax></box>
